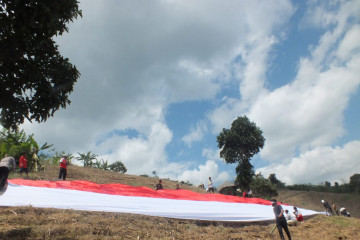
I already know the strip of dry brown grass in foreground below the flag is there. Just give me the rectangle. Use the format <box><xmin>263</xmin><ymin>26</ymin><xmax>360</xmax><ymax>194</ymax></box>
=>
<box><xmin>0</xmin><ymin>207</ymin><xmax>360</xmax><ymax>240</ymax></box>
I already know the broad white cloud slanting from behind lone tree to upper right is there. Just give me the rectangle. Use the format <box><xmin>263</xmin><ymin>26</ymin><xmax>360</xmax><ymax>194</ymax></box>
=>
<box><xmin>205</xmin><ymin>1</ymin><xmax>360</xmax><ymax>183</ymax></box>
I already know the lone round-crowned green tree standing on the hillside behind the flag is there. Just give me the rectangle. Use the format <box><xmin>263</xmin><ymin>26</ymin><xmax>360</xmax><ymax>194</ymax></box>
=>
<box><xmin>217</xmin><ymin>116</ymin><xmax>265</xmax><ymax>189</ymax></box>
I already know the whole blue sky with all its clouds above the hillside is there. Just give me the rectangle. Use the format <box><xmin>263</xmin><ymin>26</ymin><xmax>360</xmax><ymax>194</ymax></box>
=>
<box><xmin>22</xmin><ymin>0</ymin><xmax>360</xmax><ymax>185</ymax></box>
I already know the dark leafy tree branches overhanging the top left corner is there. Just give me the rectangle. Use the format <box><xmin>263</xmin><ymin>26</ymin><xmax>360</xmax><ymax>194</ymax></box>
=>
<box><xmin>0</xmin><ymin>0</ymin><xmax>81</xmax><ymax>129</ymax></box>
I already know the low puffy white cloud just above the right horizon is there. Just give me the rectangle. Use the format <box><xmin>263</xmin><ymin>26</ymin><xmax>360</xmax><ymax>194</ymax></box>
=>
<box><xmin>257</xmin><ymin>141</ymin><xmax>360</xmax><ymax>184</ymax></box>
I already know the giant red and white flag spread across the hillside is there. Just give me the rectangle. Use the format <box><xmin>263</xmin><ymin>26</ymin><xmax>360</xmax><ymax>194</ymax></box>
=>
<box><xmin>0</xmin><ymin>179</ymin><xmax>319</xmax><ymax>222</ymax></box>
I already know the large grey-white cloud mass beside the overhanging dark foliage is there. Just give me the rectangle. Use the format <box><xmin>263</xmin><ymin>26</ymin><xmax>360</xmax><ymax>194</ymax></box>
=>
<box><xmin>24</xmin><ymin>1</ymin><xmax>293</xmax><ymax>178</ymax></box>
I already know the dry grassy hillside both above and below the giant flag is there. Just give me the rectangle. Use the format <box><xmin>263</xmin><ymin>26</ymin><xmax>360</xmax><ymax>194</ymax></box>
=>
<box><xmin>0</xmin><ymin>166</ymin><xmax>360</xmax><ymax>240</ymax></box>
